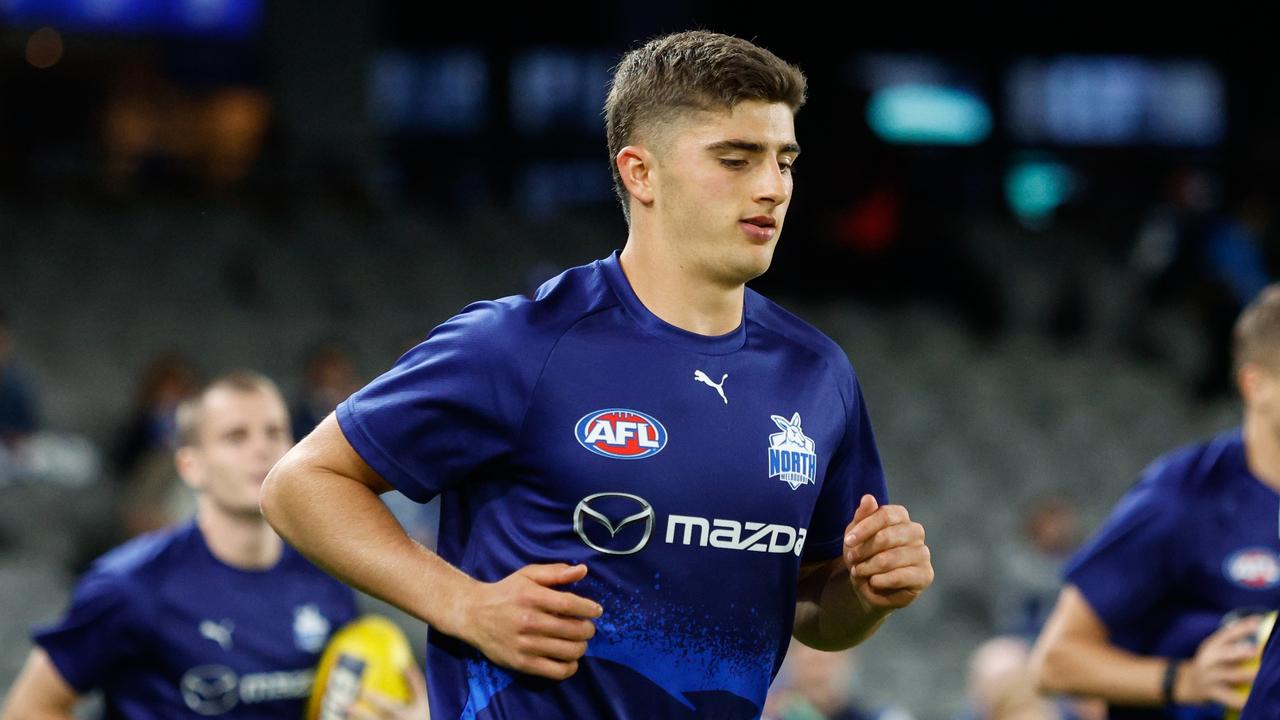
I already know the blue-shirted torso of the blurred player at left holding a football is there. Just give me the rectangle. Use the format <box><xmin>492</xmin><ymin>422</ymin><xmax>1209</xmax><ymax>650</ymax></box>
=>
<box><xmin>108</xmin><ymin>545</ymin><xmax>353</xmax><ymax>719</ymax></box>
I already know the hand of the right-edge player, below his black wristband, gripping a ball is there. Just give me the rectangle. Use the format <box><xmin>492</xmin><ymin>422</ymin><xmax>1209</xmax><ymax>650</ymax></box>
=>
<box><xmin>1174</xmin><ymin>616</ymin><xmax>1262</xmax><ymax>710</ymax></box>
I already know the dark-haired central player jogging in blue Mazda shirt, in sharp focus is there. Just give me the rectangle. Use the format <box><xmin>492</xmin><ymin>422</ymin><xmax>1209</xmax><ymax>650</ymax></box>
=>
<box><xmin>262</xmin><ymin>32</ymin><xmax>933</xmax><ymax>719</ymax></box>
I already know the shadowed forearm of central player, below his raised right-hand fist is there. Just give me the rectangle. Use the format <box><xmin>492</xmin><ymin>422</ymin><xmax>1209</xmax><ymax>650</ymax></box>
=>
<box><xmin>792</xmin><ymin>557</ymin><xmax>891</xmax><ymax>651</ymax></box>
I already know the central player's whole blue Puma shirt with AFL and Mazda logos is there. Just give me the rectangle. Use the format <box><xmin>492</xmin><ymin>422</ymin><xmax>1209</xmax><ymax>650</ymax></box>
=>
<box><xmin>338</xmin><ymin>252</ymin><xmax>887</xmax><ymax>719</ymax></box>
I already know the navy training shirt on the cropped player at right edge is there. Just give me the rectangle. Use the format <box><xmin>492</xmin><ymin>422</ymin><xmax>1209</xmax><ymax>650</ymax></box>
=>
<box><xmin>1065</xmin><ymin>429</ymin><xmax>1280</xmax><ymax>719</ymax></box>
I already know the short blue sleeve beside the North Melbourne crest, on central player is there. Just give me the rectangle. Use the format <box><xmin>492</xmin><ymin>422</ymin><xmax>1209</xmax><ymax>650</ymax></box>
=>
<box><xmin>804</xmin><ymin>369</ymin><xmax>888</xmax><ymax>562</ymax></box>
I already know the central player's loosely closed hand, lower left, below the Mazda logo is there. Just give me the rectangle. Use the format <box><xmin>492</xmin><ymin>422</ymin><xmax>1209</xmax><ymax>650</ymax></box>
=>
<box><xmin>462</xmin><ymin>564</ymin><xmax>604</xmax><ymax>680</ymax></box>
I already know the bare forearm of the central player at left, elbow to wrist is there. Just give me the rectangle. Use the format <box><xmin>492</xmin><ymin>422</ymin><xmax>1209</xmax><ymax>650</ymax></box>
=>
<box><xmin>261</xmin><ymin>456</ymin><xmax>475</xmax><ymax>635</ymax></box>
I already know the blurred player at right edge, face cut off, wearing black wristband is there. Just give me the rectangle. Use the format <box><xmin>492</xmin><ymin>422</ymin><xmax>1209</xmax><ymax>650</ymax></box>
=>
<box><xmin>1034</xmin><ymin>287</ymin><xmax>1280</xmax><ymax>719</ymax></box>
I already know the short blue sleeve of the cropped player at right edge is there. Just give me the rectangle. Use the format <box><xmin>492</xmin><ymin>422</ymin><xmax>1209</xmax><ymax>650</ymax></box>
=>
<box><xmin>1064</xmin><ymin>464</ymin><xmax>1178</xmax><ymax>632</ymax></box>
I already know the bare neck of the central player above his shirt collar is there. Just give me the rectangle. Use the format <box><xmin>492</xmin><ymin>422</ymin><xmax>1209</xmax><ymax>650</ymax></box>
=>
<box><xmin>618</xmin><ymin>233</ymin><xmax>746</xmax><ymax>336</ymax></box>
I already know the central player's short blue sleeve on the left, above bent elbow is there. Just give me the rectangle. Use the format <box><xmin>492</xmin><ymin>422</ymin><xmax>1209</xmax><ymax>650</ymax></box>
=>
<box><xmin>337</xmin><ymin>301</ymin><xmax>527</xmax><ymax>502</ymax></box>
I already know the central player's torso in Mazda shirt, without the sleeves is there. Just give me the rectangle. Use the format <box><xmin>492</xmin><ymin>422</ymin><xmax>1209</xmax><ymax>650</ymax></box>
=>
<box><xmin>437</xmin><ymin>313</ymin><xmax>846</xmax><ymax>716</ymax></box>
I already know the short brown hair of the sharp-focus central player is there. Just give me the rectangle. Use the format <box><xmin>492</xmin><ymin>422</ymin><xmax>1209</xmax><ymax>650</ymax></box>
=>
<box><xmin>604</xmin><ymin>29</ymin><xmax>808</xmax><ymax>224</ymax></box>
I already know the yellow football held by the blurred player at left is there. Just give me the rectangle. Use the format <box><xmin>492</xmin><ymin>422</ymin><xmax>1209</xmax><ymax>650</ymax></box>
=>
<box><xmin>306</xmin><ymin>615</ymin><xmax>413</xmax><ymax>720</ymax></box>
